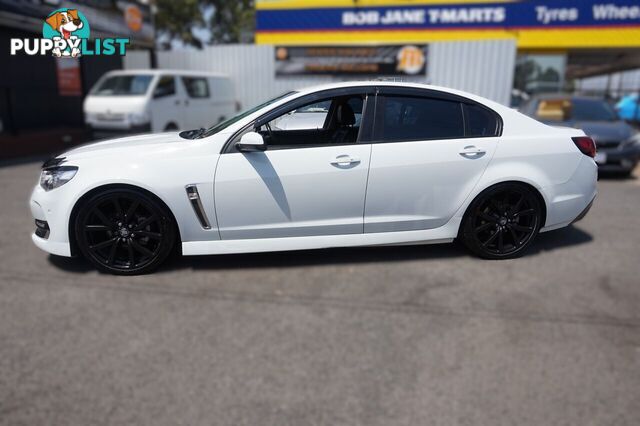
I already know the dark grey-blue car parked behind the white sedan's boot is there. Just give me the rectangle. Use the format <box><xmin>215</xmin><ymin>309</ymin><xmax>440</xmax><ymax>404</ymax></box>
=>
<box><xmin>521</xmin><ymin>94</ymin><xmax>640</xmax><ymax>175</ymax></box>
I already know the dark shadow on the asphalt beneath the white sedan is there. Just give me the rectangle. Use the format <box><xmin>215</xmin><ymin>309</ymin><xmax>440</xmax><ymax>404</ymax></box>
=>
<box><xmin>49</xmin><ymin>226</ymin><xmax>593</xmax><ymax>273</ymax></box>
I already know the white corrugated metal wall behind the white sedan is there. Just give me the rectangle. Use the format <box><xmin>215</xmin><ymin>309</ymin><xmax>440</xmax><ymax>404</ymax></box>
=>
<box><xmin>154</xmin><ymin>40</ymin><xmax>516</xmax><ymax>108</ymax></box>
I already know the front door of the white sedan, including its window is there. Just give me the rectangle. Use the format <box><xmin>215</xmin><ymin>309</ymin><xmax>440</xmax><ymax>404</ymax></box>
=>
<box><xmin>215</xmin><ymin>94</ymin><xmax>371</xmax><ymax>240</ymax></box>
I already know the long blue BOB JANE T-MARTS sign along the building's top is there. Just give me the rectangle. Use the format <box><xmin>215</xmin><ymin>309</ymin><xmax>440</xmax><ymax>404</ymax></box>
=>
<box><xmin>257</xmin><ymin>0</ymin><xmax>640</xmax><ymax>32</ymax></box>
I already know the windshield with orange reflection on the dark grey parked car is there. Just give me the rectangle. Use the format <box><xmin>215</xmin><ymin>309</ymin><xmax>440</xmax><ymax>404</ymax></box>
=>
<box><xmin>536</xmin><ymin>98</ymin><xmax>618</xmax><ymax>121</ymax></box>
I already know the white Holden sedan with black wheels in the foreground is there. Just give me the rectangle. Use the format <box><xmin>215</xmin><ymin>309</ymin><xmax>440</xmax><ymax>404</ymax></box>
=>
<box><xmin>31</xmin><ymin>82</ymin><xmax>597</xmax><ymax>274</ymax></box>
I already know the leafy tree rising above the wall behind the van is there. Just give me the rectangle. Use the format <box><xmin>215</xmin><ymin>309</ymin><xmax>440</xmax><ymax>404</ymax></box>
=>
<box><xmin>155</xmin><ymin>0</ymin><xmax>255</xmax><ymax>48</ymax></box>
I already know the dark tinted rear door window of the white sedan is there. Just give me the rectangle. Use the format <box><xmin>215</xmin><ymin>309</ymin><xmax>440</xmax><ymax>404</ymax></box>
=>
<box><xmin>375</xmin><ymin>95</ymin><xmax>464</xmax><ymax>142</ymax></box>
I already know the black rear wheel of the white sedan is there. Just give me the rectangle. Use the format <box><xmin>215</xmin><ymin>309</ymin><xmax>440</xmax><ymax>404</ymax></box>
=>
<box><xmin>460</xmin><ymin>183</ymin><xmax>543</xmax><ymax>259</ymax></box>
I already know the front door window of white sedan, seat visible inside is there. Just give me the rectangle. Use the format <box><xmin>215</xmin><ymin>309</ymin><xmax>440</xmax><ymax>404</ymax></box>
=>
<box><xmin>257</xmin><ymin>95</ymin><xmax>364</xmax><ymax>149</ymax></box>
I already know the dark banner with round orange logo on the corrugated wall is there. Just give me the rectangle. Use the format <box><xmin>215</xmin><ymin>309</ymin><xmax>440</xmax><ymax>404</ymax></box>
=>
<box><xmin>275</xmin><ymin>45</ymin><xmax>427</xmax><ymax>76</ymax></box>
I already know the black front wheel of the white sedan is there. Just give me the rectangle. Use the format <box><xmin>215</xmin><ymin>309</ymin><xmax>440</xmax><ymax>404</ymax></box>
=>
<box><xmin>75</xmin><ymin>189</ymin><xmax>176</xmax><ymax>275</ymax></box>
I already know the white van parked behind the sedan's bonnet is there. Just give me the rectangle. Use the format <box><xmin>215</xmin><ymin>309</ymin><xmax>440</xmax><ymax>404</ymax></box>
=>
<box><xmin>84</xmin><ymin>70</ymin><xmax>240</xmax><ymax>138</ymax></box>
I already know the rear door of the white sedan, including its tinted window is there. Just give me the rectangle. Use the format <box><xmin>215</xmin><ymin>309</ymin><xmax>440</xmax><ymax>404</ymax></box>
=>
<box><xmin>364</xmin><ymin>88</ymin><xmax>501</xmax><ymax>232</ymax></box>
